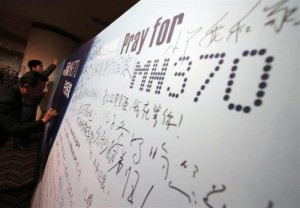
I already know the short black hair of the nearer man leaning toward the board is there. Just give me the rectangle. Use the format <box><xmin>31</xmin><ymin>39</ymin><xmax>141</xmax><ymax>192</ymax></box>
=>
<box><xmin>18</xmin><ymin>71</ymin><xmax>48</xmax><ymax>87</ymax></box>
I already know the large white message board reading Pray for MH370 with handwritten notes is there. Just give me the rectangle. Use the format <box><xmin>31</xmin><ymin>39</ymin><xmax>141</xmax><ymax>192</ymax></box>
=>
<box><xmin>36</xmin><ymin>1</ymin><xmax>300</xmax><ymax>208</ymax></box>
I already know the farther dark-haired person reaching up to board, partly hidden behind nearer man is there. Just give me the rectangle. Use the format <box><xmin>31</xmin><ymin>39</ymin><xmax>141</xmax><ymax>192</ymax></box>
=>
<box><xmin>14</xmin><ymin>58</ymin><xmax>58</xmax><ymax>150</ymax></box>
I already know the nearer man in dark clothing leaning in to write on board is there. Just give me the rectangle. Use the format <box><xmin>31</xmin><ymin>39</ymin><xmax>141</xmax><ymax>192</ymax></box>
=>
<box><xmin>0</xmin><ymin>71</ymin><xmax>58</xmax><ymax>147</ymax></box>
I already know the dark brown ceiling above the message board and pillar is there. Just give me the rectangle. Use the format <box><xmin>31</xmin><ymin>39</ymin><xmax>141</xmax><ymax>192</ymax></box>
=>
<box><xmin>0</xmin><ymin>0</ymin><xmax>138</xmax><ymax>54</ymax></box>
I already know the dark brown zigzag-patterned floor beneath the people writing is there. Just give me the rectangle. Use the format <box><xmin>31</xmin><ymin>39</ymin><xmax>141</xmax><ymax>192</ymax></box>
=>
<box><xmin>0</xmin><ymin>138</ymin><xmax>38</xmax><ymax>208</ymax></box>
